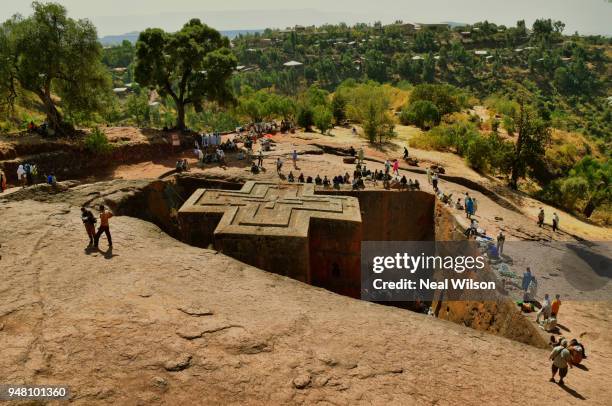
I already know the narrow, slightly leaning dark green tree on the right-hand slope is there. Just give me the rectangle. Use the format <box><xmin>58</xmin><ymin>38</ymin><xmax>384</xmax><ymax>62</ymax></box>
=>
<box><xmin>510</xmin><ymin>99</ymin><xmax>550</xmax><ymax>189</ymax></box>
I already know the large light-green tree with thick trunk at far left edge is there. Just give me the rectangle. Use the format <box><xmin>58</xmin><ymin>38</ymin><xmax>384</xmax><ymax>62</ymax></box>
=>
<box><xmin>0</xmin><ymin>2</ymin><xmax>110</xmax><ymax>133</ymax></box>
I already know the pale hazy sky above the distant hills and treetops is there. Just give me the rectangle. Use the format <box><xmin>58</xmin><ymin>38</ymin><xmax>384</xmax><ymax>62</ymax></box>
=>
<box><xmin>0</xmin><ymin>0</ymin><xmax>612</xmax><ymax>36</ymax></box>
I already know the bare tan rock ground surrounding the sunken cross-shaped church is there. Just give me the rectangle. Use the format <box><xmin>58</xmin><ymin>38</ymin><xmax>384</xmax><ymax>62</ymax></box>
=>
<box><xmin>0</xmin><ymin>126</ymin><xmax>612</xmax><ymax>405</ymax></box>
